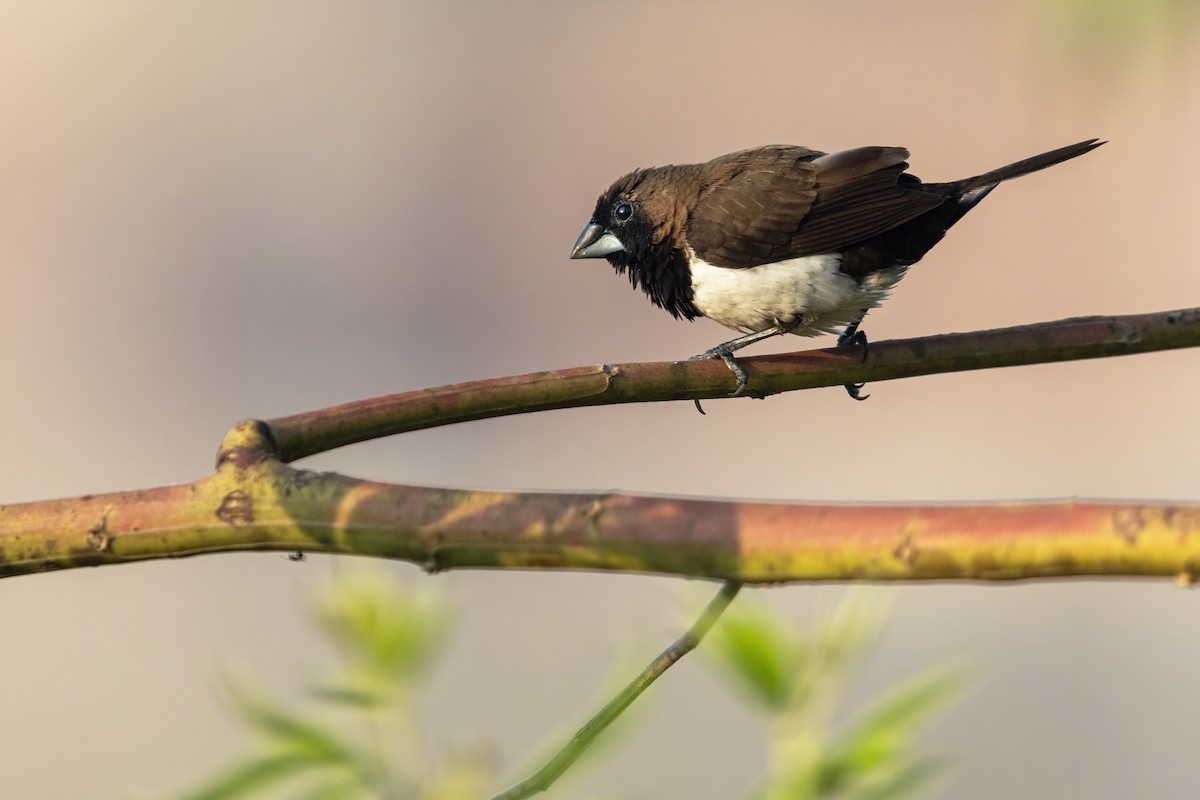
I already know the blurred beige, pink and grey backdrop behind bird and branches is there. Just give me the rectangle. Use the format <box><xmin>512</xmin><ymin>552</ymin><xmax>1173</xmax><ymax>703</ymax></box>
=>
<box><xmin>0</xmin><ymin>0</ymin><xmax>1200</xmax><ymax>800</ymax></box>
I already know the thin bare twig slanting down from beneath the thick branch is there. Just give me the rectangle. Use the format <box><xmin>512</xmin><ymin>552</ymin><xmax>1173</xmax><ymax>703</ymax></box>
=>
<box><xmin>492</xmin><ymin>581</ymin><xmax>742</xmax><ymax>800</ymax></box>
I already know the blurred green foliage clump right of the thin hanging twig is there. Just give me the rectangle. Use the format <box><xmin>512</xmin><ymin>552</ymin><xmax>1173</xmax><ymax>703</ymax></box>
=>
<box><xmin>704</xmin><ymin>599</ymin><xmax>962</xmax><ymax>800</ymax></box>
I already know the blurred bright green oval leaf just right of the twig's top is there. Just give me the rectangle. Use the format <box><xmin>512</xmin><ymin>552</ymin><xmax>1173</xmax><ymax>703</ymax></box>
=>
<box><xmin>707</xmin><ymin>602</ymin><xmax>804</xmax><ymax>710</ymax></box>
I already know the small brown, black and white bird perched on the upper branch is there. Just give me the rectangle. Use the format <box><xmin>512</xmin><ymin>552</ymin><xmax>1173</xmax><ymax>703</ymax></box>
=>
<box><xmin>571</xmin><ymin>139</ymin><xmax>1105</xmax><ymax>414</ymax></box>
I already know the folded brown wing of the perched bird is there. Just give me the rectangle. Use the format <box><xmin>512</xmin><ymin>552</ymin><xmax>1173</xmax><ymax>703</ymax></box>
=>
<box><xmin>688</xmin><ymin>148</ymin><xmax>946</xmax><ymax>267</ymax></box>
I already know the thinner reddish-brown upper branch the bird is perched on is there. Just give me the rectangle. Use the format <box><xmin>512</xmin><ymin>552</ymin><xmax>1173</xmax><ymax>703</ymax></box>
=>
<box><xmin>269</xmin><ymin>308</ymin><xmax>1200</xmax><ymax>462</ymax></box>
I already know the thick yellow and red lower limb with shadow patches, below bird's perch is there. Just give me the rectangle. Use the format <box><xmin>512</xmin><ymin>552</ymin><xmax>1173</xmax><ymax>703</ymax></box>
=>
<box><xmin>0</xmin><ymin>422</ymin><xmax>1200</xmax><ymax>583</ymax></box>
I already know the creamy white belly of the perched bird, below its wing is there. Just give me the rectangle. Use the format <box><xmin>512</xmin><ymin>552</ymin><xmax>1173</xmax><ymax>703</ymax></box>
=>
<box><xmin>691</xmin><ymin>254</ymin><xmax>905</xmax><ymax>336</ymax></box>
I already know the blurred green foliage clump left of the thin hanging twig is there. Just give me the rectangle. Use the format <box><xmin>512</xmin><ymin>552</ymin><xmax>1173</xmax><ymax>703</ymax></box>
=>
<box><xmin>170</xmin><ymin>571</ymin><xmax>491</xmax><ymax>800</ymax></box>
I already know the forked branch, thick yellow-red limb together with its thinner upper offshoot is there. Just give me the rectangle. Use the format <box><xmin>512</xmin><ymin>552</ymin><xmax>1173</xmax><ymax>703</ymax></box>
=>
<box><xmin>0</xmin><ymin>309</ymin><xmax>1200</xmax><ymax>583</ymax></box>
